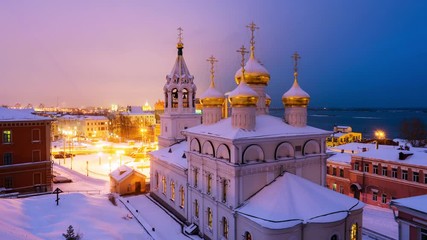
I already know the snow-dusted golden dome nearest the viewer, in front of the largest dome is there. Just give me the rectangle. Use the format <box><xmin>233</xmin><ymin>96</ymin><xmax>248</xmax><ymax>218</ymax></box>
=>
<box><xmin>228</xmin><ymin>82</ymin><xmax>258</xmax><ymax>107</ymax></box>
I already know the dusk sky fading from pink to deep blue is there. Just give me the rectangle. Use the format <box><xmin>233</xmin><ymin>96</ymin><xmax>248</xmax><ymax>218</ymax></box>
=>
<box><xmin>0</xmin><ymin>0</ymin><xmax>427</xmax><ymax>108</ymax></box>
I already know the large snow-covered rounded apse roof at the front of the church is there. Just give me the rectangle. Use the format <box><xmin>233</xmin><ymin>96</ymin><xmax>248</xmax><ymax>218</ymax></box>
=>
<box><xmin>236</xmin><ymin>173</ymin><xmax>364</xmax><ymax>229</ymax></box>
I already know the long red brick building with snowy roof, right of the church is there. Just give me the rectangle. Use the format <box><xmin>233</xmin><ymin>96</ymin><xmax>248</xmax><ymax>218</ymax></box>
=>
<box><xmin>326</xmin><ymin>143</ymin><xmax>427</xmax><ymax>207</ymax></box>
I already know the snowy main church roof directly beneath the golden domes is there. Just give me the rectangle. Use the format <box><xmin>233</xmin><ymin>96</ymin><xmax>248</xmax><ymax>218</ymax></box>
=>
<box><xmin>184</xmin><ymin>115</ymin><xmax>331</xmax><ymax>139</ymax></box>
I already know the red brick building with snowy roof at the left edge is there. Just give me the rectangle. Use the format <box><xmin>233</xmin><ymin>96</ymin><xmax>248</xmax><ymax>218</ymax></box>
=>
<box><xmin>0</xmin><ymin>108</ymin><xmax>52</xmax><ymax>194</ymax></box>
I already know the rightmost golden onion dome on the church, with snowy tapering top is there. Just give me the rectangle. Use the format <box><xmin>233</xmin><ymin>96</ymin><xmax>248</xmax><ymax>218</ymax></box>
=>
<box><xmin>282</xmin><ymin>72</ymin><xmax>310</xmax><ymax>107</ymax></box>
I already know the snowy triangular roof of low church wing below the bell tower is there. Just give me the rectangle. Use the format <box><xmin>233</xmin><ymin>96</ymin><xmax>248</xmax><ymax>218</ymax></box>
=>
<box><xmin>150</xmin><ymin>141</ymin><xmax>188</xmax><ymax>169</ymax></box>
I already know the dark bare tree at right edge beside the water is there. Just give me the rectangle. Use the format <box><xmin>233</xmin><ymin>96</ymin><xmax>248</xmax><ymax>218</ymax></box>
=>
<box><xmin>400</xmin><ymin>118</ymin><xmax>427</xmax><ymax>147</ymax></box>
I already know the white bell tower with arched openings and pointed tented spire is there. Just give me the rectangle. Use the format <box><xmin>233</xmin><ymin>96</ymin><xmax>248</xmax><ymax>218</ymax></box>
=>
<box><xmin>159</xmin><ymin>28</ymin><xmax>201</xmax><ymax>148</ymax></box>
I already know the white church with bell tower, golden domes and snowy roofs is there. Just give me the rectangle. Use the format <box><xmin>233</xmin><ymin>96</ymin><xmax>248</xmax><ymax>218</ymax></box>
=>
<box><xmin>150</xmin><ymin>23</ymin><xmax>363</xmax><ymax>240</ymax></box>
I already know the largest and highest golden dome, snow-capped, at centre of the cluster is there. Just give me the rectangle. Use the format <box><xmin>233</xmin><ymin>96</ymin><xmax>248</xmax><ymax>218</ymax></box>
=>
<box><xmin>234</xmin><ymin>52</ymin><xmax>270</xmax><ymax>85</ymax></box>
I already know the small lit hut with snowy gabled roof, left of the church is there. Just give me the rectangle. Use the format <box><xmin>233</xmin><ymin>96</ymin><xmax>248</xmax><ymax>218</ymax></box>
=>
<box><xmin>110</xmin><ymin>165</ymin><xmax>146</xmax><ymax>195</ymax></box>
